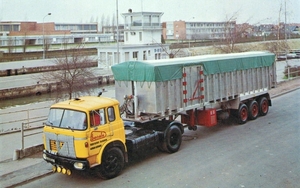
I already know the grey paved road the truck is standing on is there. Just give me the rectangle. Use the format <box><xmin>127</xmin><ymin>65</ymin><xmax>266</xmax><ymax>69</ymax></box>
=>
<box><xmin>15</xmin><ymin>89</ymin><xmax>300</xmax><ymax>188</ymax></box>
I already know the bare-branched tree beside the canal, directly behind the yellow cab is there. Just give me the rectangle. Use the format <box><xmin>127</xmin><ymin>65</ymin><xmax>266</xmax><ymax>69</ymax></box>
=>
<box><xmin>39</xmin><ymin>45</ymin><xmax>95</xmax><ymax>99</ymax></box>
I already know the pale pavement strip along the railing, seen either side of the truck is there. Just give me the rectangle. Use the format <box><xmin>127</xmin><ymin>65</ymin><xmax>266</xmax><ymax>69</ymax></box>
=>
<box><xmin>0</xmin><ymin>78</ymin><xmax>300</xmax><ymax>187</ymax></box>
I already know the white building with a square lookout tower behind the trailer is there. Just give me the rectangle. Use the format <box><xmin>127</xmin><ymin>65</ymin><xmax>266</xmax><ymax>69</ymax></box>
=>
<box><xmin>97</xmin><ymin>9</ymin><xmax>169</xmax><ymax>68</ymax></box>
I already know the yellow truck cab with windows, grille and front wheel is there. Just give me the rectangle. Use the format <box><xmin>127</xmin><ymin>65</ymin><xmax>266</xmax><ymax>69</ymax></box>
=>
<box><xmin>43</xmin><ymin>96</ymin><xmax>127</xmax><ymax>178</ymax></box>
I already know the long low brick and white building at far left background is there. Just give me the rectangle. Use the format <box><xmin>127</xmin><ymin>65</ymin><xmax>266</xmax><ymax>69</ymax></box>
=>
<box><xmin>0</xmin><ymin>22</ymin><xmax>113</xmax><ymax>46</ymax></box>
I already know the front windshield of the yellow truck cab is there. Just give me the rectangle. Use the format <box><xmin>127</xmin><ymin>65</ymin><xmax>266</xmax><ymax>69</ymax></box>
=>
<box><xmin>46</xmin><ymin>108</ymin><xmax>87</xmax><ymax>130</ymax></box>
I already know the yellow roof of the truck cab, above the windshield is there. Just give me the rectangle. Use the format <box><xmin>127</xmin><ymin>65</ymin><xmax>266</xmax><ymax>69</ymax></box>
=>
<box><xmin>51</xmin><ymin>96</ymin><xmax>119</xmax><ymax>111</ymax></box>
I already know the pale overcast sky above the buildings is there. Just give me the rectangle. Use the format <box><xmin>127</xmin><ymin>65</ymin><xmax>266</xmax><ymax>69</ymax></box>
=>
<box><xmin>0</xmin><ymin>0</ymin><xmax>300</xmax><ymax>24</ymax></box>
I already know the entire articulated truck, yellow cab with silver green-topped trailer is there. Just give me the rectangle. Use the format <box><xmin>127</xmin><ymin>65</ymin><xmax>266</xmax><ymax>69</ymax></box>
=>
<box><xmin>43</xmin><ymin>52</ymin><xmax>276</xmax><ymax>179</ymax></box>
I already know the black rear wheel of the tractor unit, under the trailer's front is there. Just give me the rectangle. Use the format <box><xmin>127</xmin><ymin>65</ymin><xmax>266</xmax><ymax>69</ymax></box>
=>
<box><xmin>163</xmin><ymin>125</ymin><xmax>182</xmax><ymax>153</ymax></box>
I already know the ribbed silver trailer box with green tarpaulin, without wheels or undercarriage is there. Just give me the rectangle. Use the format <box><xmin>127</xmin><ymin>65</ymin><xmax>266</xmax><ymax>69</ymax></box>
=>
<box><xmin>112</xmin><ymin>52</ymin><xmax>276</xmax><ymax>119</ymax></box>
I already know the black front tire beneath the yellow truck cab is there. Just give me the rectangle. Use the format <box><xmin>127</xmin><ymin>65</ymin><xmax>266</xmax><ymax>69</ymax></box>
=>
<box><xmin>96</xmin><ymin>147</ymin><xmax>124</xmax><ymax>179</ymax></box>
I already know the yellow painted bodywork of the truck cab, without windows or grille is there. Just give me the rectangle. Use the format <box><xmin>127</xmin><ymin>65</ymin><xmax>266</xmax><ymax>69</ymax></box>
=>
<box><xmin>43</xmin><ymin>96</ymin><xmax>126</xmax><ymax>166</ymax></box>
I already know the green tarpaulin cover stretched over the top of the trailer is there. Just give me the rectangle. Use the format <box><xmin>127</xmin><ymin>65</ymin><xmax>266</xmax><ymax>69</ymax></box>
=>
<box><xmin>112</xmin><ymin>52</ymin><xmax>275</xmax><ymax>82</ymax></box>
